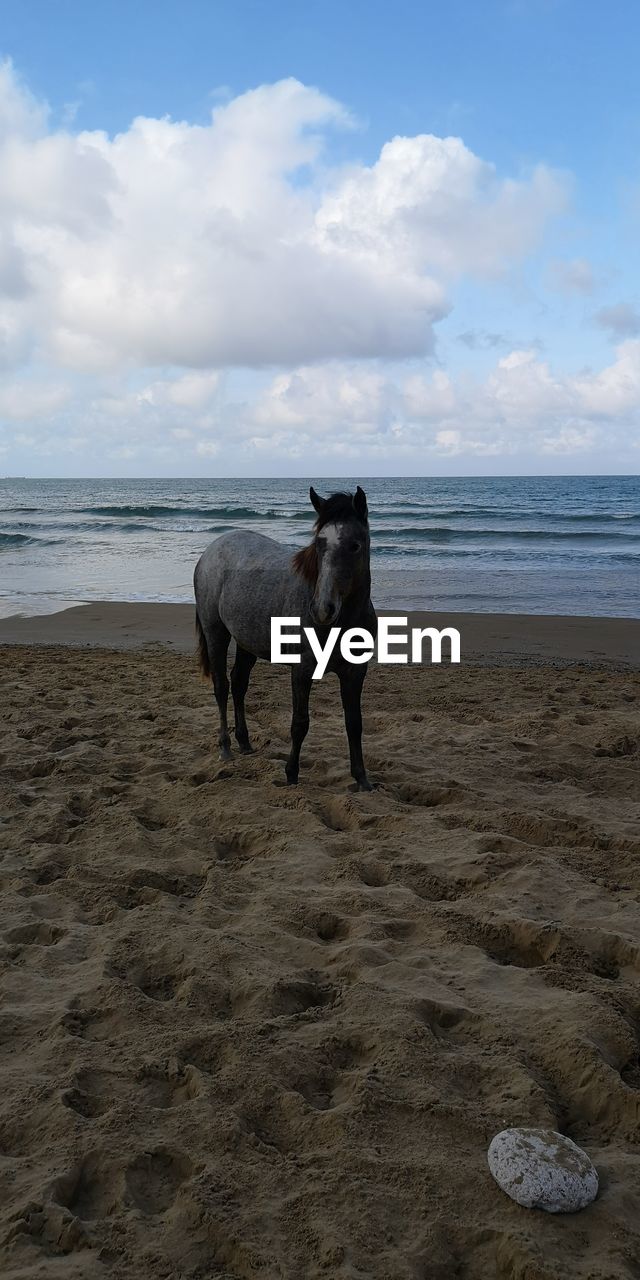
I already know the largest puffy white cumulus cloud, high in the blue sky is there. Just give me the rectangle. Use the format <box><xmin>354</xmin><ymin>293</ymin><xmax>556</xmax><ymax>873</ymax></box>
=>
<box><xmin>0</xmin><ymin>63</ymin><xmax>566</xmax><ymax>371</ymax></box>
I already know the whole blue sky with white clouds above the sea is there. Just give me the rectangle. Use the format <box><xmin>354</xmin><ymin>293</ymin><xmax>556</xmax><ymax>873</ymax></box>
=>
<box><xmin>0</xmin><ymin>0</ymin><xmax>640</xmax><ymax>476</ymax></box>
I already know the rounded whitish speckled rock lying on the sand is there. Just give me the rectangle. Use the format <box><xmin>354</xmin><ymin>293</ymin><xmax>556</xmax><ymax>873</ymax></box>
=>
<box><xmin>488</xmin><ymin>1129</ymin><xmax>598</xmax><ymax>1213</ymax></box>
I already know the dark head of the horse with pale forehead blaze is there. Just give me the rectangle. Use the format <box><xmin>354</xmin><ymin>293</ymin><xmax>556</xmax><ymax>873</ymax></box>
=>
<box><xmin>293</xmin><ymin>485</ymin><xmax>371</xmax><ymax>626</ymax></box>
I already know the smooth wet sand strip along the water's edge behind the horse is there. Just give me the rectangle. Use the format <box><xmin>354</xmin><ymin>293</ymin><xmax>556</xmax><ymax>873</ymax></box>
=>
<box><xmin>0</xmin><ymin>600</ymin><xmax>640</xmax><ymax>669</ymax></box>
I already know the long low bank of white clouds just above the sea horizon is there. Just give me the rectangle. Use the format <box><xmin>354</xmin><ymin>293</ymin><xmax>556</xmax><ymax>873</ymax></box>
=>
<box><xmin>0</xmin><ymin>339</ymin><xmax>640</xmax><ymax>474</ymax></box>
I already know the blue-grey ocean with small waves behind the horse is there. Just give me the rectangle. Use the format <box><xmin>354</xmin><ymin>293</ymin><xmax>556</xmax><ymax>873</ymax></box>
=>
<box><xmin>0</xmin><ymin>476</ymin><xmax>640</xmax><ymax>617</ymax></box>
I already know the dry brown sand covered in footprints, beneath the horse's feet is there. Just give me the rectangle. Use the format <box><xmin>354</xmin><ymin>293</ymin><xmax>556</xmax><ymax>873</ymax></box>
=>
<box><xmin>0</xmin><ymin>646</ymin><xmax>640</xmax><ymax>1280</ymax></box>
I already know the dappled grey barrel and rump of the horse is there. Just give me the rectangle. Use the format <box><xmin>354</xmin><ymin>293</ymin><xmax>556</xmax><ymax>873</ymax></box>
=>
<box><xmin>193</xmin><ymin>529</ymin><xmax>305</xmax><ymax>658</ymax></box>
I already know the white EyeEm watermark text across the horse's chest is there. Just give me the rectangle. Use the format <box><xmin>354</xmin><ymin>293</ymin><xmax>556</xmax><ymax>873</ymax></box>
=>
<box><xmin>271</xmin><ymin>617</ymin><xmax>460</xmax><ymax>680</ymax></box>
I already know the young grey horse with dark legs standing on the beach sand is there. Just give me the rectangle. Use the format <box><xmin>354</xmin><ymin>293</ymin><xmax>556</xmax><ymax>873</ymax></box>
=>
<box><xmin>193</xmin><ymin>485</ymin><xmax>378</xmax><ymax>791</ymax></box>
